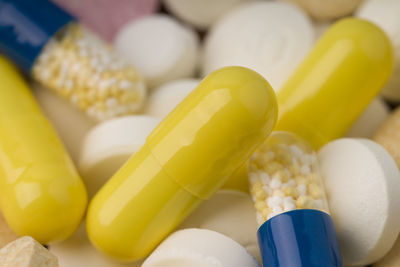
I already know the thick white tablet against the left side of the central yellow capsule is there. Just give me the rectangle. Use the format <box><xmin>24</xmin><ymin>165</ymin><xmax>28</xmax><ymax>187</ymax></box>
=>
<box><xmin>79</xmin><ymin>115</ymin><xmax>160</xmax><ymax>197</ymax></box>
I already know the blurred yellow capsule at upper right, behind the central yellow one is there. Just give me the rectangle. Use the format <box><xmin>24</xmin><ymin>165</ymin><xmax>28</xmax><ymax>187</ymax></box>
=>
<box><xmin>276</xmin><ymin>18</ymin><xmax>393</xmax><ymax>149</ymax></box>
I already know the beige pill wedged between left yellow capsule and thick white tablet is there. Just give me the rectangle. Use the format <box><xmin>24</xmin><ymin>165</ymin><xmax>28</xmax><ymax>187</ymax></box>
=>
<box><xmin>33</xmin><ymin>84</ymin><xmax>95</xmax><ymax>164</ymax></box>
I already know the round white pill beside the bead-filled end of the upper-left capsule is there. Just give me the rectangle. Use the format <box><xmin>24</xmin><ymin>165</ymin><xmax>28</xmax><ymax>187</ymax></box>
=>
<box><xmin>114</xmin><ymin>14</ymin><xmax>199</xmax><ymax>88</ymax></box>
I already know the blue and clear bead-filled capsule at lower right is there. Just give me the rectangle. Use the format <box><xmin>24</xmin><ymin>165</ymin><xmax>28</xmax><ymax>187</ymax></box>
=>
<box><xmin>248</xmin><ymin>132</ymin><xmax>342</xmax><ymax>267</ymax></box>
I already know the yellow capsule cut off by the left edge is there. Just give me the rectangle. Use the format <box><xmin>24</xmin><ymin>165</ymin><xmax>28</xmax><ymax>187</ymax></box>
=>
<box><xmin>0</xmin><ymin>57</ymin><xmax>87</xmax><ymax>244</ymax></box>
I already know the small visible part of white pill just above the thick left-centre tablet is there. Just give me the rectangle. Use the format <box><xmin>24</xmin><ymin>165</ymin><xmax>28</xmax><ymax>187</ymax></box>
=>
<box><xmin>145</xmin><ymin>79</ymin><xmax>200</xmax><ymax>119</ymax></box>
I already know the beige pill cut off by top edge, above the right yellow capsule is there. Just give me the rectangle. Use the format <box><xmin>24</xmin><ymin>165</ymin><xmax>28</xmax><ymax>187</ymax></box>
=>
<box><xmin>285</xmin><ymin>0</ymin><xmax>366</xmax><ymax>20</ymax></box>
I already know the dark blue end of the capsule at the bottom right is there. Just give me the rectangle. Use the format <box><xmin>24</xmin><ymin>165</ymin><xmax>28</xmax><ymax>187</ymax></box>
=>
<box><xmin>258</xmin><ymin>209</ymin><xmax>343</xmax><ymax>267</ymax></box>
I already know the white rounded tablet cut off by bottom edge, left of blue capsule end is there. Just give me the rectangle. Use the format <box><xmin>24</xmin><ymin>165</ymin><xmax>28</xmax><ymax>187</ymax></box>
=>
<box><xmin>142</xmin><ymin>229</ymin><xmax>260</xmax><ymax>267</ymax></box>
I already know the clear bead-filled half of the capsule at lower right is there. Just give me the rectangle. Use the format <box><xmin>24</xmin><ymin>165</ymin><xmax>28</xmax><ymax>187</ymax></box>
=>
<box><xmin>248</xmin><ymin>132</ymin><xmax>329</xmax><ymax>225</ymax></box>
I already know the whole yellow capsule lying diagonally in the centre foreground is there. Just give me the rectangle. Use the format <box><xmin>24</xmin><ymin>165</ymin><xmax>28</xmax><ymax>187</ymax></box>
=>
<box><xmin>86</xmin><ymin>67</ymin><xmax>277</xmax><ymax>261</ymax></box>
